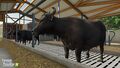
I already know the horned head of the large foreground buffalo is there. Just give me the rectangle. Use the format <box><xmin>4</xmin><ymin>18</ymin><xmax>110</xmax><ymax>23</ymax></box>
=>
<box><xmin>33</xmin><ymin>7</ymin><xmax>56</xmax><ymax>37</ymax></box>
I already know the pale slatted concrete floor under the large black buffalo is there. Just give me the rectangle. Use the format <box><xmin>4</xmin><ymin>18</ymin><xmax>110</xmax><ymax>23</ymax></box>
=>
<box><xmin>16</xmin><ymin>43</ymin><xmax>120</xmax><ymax>68</ymax></box>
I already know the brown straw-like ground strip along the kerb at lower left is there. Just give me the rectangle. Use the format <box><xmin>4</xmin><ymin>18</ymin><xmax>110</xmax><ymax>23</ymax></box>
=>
<box><xmin>0</xmin><ymin>39</ymin><xmax>67</xmax><ymax>68</ymax></box>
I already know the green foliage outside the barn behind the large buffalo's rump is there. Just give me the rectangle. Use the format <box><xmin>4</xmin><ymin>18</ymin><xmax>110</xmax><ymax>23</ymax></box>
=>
<box><xmin>102</xmin><ymin>16</ymin><xmax>120</xmax><ymax>30</ymax></box>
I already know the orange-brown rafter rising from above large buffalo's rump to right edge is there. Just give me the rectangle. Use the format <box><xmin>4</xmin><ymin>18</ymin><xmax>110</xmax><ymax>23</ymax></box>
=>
<box><xmin>90</xmin><ymin>4</ymin><xmax>120</xmax><ymax>19</ymax></box>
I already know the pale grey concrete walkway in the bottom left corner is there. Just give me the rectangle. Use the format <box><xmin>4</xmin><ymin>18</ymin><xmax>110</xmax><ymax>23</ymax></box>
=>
<box><xmin>0</xmin><ymin>48</ymin><xmax>14</xmax><ymax>68</ymax></box>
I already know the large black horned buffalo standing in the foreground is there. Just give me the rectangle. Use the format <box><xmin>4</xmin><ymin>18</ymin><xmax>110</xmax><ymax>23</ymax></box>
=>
<box><xmin>33</xmin><ymin>8</ymin><xmax>106</xmax><ymax>62</ymax></box>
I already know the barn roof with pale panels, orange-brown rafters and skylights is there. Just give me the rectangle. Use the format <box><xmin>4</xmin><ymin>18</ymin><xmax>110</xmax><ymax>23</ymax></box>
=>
<box><xmin>0</xmin><ymin>0</ymin><xmax>120</xmax><ymax>20</ymax></box>
